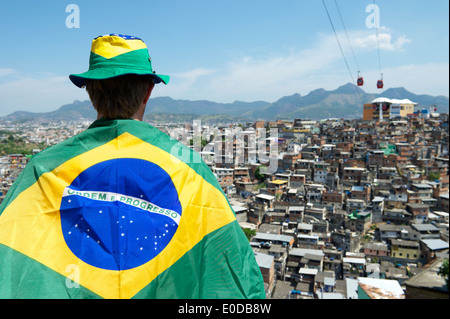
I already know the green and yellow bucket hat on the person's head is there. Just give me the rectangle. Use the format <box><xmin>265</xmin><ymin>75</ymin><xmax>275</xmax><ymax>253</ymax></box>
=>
<box><xmin>69</xmin><ymin>34</ymin><xmax>170</xmax><ymax>88</ymax></box>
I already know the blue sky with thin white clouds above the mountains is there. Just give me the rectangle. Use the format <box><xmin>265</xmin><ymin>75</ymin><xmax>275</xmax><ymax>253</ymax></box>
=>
<box><xmin>0</xmin><ymin>0</ymin><xmax>449</xmax><ymax>116</ymax></box>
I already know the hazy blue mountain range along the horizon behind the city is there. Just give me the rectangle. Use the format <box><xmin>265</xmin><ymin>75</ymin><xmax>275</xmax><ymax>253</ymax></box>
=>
<box><xmin>0</xmin><ymin>83</ymin><xmax>449</xmax><ymax>121</ymax></box>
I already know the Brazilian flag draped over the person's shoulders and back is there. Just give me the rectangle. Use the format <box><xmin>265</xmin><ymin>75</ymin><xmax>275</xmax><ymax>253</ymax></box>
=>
<box><xmin>0</xmin><ymin>119</ymin><xmax>265</xmax><ymax>299</ymax></box>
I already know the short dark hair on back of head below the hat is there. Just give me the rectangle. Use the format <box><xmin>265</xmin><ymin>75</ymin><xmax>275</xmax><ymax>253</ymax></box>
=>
<box><xmin>86</xmin><ymin>74</ymin><xmax>153</xmax><ymax>119</ymax></box>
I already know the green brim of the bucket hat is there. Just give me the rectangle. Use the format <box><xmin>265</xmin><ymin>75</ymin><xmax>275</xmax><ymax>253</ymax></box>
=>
<box><xmin>69</xmin><ymin>68</ymin><xmax>170</xmax><ymax>88</ymax></box>
